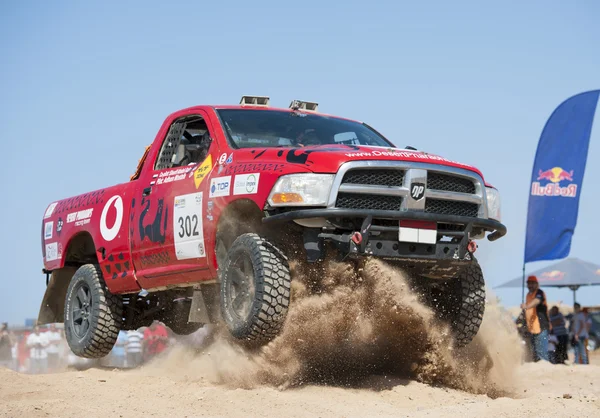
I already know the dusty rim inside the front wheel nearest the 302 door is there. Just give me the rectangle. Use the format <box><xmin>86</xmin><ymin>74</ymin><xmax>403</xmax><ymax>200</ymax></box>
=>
<box><xmin>228</xmin><ymin>254</ymin><xmax>256</xmax><ymax>319</ymax></box>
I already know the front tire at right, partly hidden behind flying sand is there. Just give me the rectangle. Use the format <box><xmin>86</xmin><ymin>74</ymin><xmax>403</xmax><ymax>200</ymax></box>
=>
<box><xmin>433</xmin><ymin>258</ymin><xmax>485</xmax><ymax>347</ymax></box>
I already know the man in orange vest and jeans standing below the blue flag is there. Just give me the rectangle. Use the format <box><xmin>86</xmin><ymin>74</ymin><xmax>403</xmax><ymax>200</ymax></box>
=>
<box><xmin>521</xmin><ymin>276</ymin><xmax>550</xmax><ymax>361</ymax></box>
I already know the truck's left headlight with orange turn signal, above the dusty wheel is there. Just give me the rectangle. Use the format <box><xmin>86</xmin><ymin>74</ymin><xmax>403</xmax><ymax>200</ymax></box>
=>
<box><xmin>268</xmin><ymin>173</ymin><xmax>334</xmax><ymax>206</ymax></box>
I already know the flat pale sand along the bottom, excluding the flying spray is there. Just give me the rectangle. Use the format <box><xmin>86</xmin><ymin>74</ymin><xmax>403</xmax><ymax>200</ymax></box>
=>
<box><xmin>0</xmin><ymin>356</ymin><xmax>600</xmax><ymax>417</ymax></box>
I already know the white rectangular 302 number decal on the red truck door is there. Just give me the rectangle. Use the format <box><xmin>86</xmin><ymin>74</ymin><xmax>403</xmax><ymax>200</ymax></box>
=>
<box><xmin>173</xmin><ymin>192</ymin><xmax>206</xmax><ymax>260</ymax></box>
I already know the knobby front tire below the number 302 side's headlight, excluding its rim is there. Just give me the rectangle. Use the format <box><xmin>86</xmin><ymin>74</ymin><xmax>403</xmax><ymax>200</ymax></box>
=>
<box><xmin>220</xmin><ymin>233</ymin><xmax>291</xmax><ymax>347</ymax></box>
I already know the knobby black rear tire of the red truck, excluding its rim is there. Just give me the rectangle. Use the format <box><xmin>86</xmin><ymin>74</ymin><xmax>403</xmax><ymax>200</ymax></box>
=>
<box><xmin>64</xmin><ymin>264</ymin><xmax>123</xmax><ymax>358</ymax></box>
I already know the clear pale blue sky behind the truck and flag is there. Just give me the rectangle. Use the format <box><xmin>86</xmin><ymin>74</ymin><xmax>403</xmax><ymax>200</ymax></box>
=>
<box><xmin>0</xmin><ymin>0</ymin><xmax>600</xmax><ymax>324</ymax></box>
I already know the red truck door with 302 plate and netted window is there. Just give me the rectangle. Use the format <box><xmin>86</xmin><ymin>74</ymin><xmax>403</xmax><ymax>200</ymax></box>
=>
<box><xmin>130</xmin><ymin>111</ymin><xmax>219</xmax><ymax>289</ymax></box>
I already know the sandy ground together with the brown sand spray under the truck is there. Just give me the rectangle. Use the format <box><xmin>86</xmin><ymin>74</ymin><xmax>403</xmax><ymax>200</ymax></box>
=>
<box><xmin>0</xmin><ymin>262</ymin><xmax>600</xmax><ymax>418</ymax></box>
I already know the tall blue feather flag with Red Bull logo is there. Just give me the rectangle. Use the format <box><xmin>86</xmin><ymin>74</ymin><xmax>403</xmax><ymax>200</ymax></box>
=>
<box><xmin>525</xmin><ymin>90</ymin><xmax>600</xmax><ymax>263</ymax></box>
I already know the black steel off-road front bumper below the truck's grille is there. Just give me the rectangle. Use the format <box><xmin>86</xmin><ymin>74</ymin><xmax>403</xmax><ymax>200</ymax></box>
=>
<box><xmin>263</xmin><ymin>208</ymin><xmax>507</xmax><ymax>274</ymax></box>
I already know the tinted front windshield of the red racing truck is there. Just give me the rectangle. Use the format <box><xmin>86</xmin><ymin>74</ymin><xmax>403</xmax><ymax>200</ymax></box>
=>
<box><xmin>217</xmin><ymin>109</ymin><xmax>395</xmax><ymax>148</ymax></box>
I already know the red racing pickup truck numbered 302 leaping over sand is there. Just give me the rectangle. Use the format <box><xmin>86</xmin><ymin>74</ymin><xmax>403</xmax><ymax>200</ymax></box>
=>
<box><xmin>38</xmin><ymin>96</ymin><xmax>506</xmax><ymax>358</ymax></box>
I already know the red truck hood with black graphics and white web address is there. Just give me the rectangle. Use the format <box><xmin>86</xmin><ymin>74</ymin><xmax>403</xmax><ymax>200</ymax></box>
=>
<box><xmin>234</xmin><ymin>145</ymin><xmax>483</xmax><ymax>178</ymax></box>
